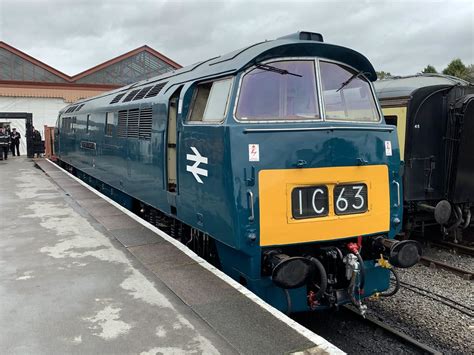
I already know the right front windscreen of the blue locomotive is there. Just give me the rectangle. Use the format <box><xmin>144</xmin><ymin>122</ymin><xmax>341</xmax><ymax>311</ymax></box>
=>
<box><xmin>320</xmin><ymin>61</ymin><xmax>380</xmax><ymax>122</ymax></box>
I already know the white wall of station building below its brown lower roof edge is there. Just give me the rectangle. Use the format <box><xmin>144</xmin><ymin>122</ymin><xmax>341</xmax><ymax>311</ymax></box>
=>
<box><xmin>0</xmin><ymin>97</ymin><xmax>67</xmax><ymax>155</ymax></box>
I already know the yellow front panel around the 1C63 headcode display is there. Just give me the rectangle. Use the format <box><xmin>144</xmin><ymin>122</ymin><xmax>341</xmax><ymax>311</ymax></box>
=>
<box><xmin>259</xmin><ymin>165</ymin><xmax>390</xmax><ymax>246</ymax></box>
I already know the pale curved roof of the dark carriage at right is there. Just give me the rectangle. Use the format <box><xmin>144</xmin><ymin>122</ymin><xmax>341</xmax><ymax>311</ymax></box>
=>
<box><xmin>374</xmin><ymin>74</ymin><xmax>470</xmax><ymax>99</ymax></box>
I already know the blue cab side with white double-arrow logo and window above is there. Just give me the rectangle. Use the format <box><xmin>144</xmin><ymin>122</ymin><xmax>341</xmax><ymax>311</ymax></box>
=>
<box><xmin>178</xmin><ymin>77</ymin><xmax>236</xmax><ymax>245</ymax></box>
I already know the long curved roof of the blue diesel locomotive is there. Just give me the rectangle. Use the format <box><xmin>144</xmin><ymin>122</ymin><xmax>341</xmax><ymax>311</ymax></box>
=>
<box><xmin>61</xmin><ymin>32</ymin><xmax>377</xmax><ymax>112</ymax></box>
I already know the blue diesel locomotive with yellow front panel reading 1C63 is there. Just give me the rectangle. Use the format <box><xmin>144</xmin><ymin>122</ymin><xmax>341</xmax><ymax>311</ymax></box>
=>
<box><xmin>55</xmin><ymin>32</ymin><xmax>420</xmax><ymax>312</ymax></box>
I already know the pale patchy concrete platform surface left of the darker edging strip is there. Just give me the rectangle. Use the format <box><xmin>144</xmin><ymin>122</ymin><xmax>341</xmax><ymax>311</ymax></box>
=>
<box><xmin>0</xmin><ymin>158</ymin><xmax>236</xmax><ymax>354</ymax></box>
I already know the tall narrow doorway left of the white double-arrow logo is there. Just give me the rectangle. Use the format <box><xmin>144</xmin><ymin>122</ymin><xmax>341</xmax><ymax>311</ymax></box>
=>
<box><xmin>166</xmin><ymin>88</ymin><xmax>181</xmax><ymax>192</ymax></box>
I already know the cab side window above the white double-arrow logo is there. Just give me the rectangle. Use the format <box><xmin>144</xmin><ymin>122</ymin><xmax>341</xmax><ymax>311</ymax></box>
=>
<box><xmin>188</xmin><ymin>78</ymin><xmax>232</xmax><ymax>123</ymax></box>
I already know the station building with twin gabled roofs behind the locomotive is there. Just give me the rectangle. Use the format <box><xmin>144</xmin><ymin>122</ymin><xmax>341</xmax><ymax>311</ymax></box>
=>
<box><xmin>0</xmin><ymin>41</ymin><xmax>181</xmax><ymax>154</ymax></box>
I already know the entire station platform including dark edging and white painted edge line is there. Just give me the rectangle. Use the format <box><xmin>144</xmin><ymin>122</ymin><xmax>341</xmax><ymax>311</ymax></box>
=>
<box><xmin>0</xmin><ymin>157</ymin><xmax>342</xmax><ymax>355</ymax></box>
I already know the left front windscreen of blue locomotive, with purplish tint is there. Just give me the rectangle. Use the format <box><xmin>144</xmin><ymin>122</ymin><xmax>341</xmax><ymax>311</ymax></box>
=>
<box><xmin>235</xmin><ymin>60</ymin><xmax>320</xmax><ymax>121</ymax></box>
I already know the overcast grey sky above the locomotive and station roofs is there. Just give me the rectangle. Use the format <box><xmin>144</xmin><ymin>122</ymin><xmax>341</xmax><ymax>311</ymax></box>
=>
<box><xmin>0</xmin><ymin>0</ymin><xmax>474</xmax><ymax>75</ymax></box>
